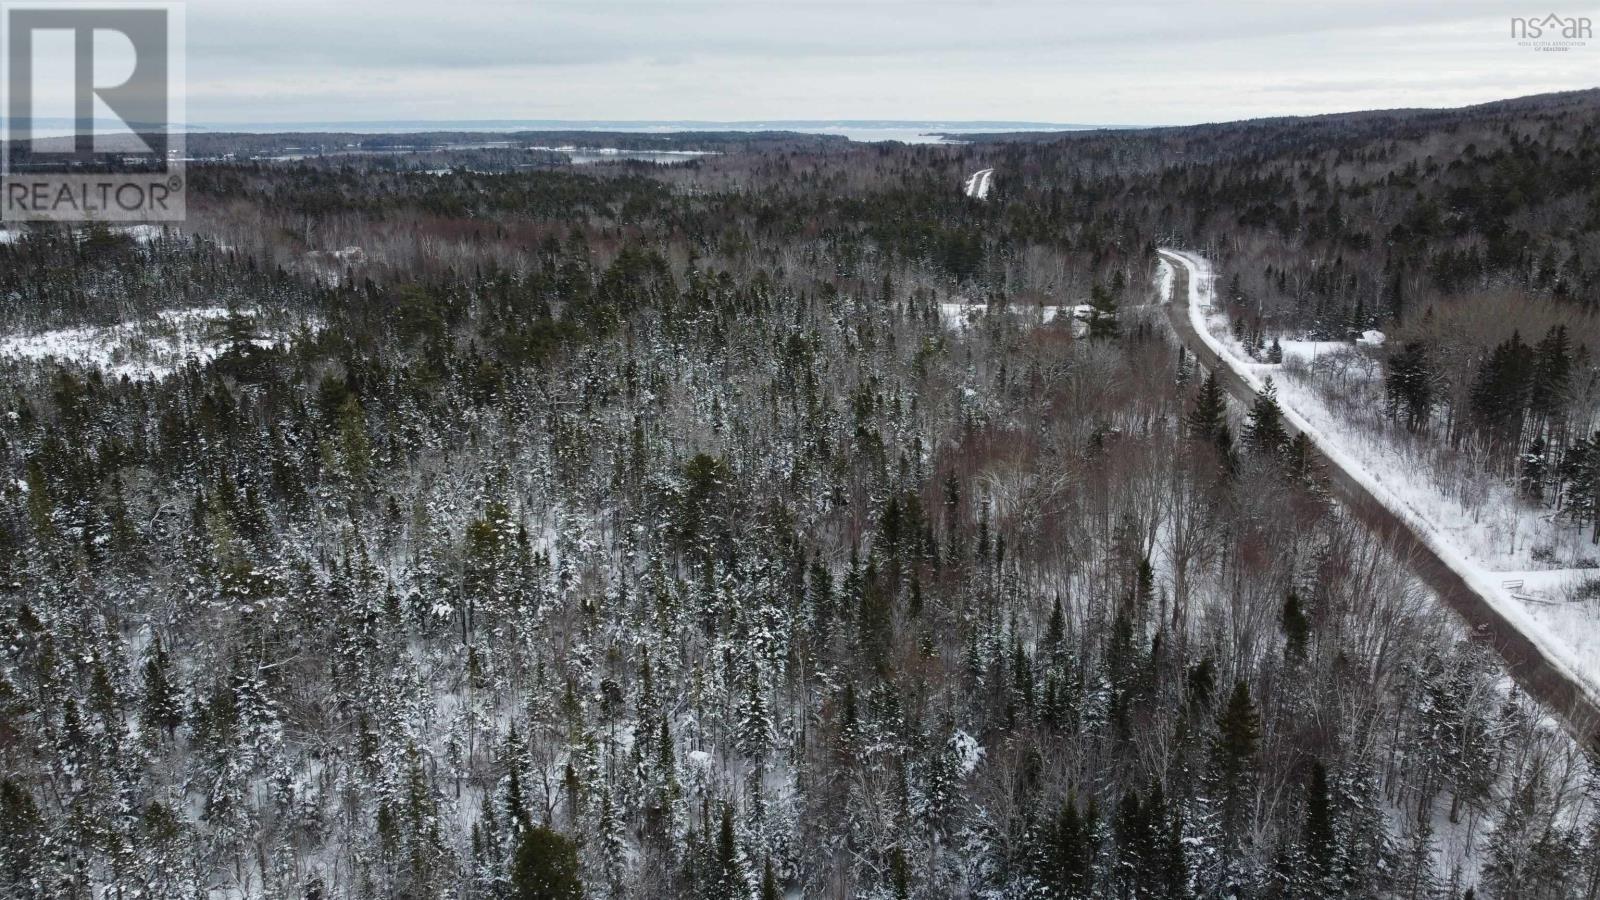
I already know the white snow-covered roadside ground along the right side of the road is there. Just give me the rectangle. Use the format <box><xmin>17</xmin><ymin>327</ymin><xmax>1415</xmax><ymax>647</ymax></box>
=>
<box><xmin>1162</xmin><ymin>250</ymin><xmax>1600</xmax><ymax>701</ymax></box>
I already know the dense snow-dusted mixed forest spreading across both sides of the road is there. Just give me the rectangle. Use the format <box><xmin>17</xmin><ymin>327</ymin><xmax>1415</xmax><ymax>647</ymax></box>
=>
<box><xmin>0</xmin><ymin>93</ymin><xmax>1600</xmax><ymax>900</ymax></box>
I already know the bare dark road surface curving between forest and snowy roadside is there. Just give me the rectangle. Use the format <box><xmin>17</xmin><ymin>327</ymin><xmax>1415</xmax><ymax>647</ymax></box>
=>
<box><xmin>1160</xmin><ymin>250</ymin><xmax>1600</xmax><ymax>748</ymax></box>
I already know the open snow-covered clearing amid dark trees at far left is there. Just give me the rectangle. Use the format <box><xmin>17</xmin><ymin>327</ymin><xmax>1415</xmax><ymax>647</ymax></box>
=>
<box><xmin>0</xmin><ymin>307</ymin><xmax>317</xmax><ymax>381</ymax></box>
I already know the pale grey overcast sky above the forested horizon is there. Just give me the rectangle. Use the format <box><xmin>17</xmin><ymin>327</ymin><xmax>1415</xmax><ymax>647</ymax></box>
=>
<box><xmin>168</xmin><ymin>0</ymin><xmax>1600</xmax><ymax>125</ymax></box>
